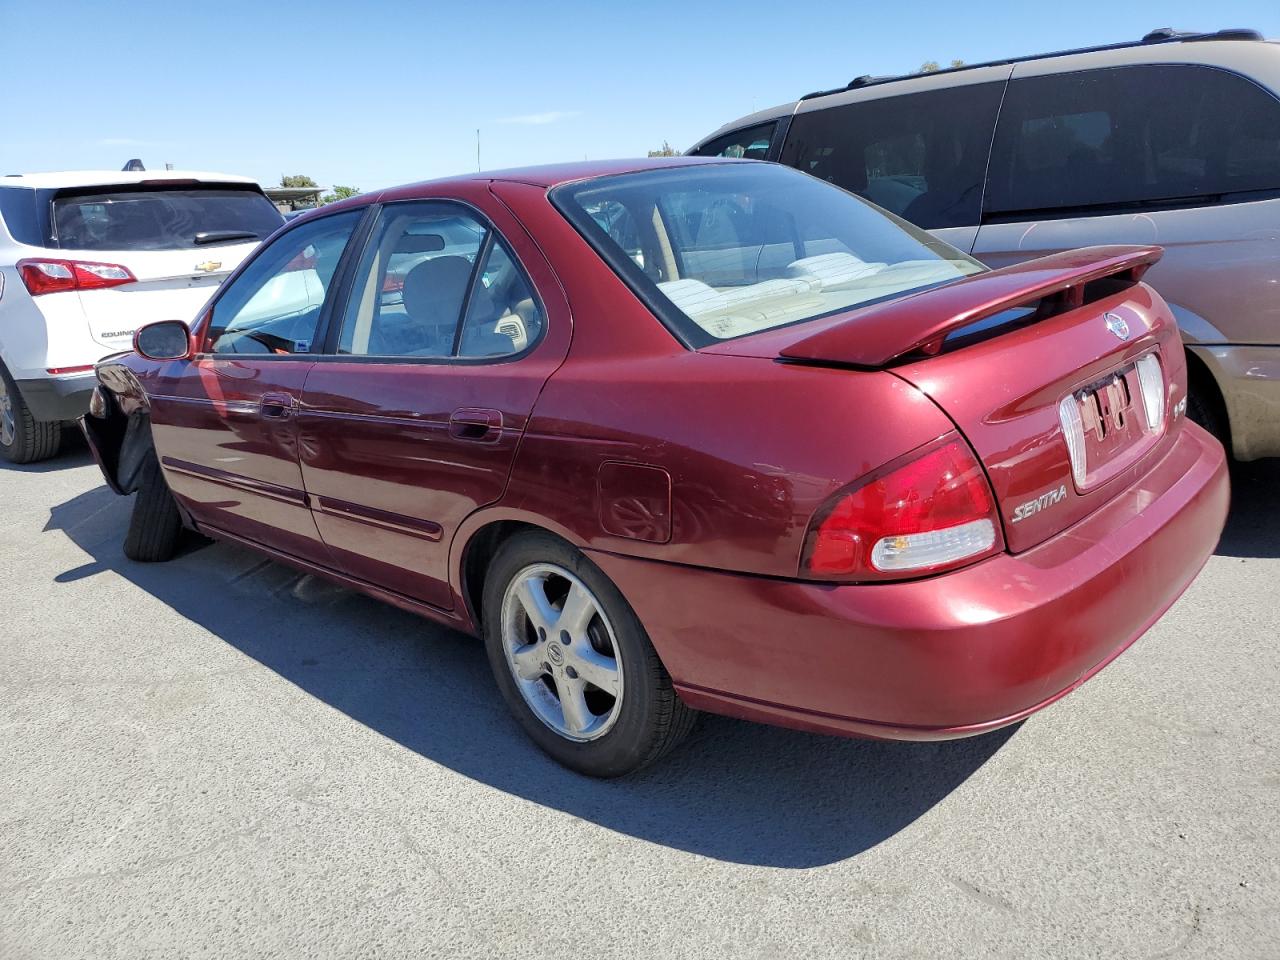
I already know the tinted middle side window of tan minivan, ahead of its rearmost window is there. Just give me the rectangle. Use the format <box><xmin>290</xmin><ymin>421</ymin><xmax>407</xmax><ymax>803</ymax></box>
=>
<box><xmin>780</xmin><ymin>83</ymin><xmax>1005</xmax><ymax>229</ymax></box>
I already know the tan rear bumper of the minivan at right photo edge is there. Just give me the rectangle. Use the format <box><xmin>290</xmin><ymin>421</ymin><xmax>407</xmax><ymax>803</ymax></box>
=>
<box><xmin>1188</xmin><ymin>344</ymin><xmax>1280</xmax><ymax>460</ymax></box>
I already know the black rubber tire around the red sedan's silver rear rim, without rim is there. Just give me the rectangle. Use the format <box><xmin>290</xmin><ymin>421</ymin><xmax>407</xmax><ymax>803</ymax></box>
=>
<box><xmin>481</xmin><ymin>534</ymin><xmax>698</xmax><ymax>777</ymax></box>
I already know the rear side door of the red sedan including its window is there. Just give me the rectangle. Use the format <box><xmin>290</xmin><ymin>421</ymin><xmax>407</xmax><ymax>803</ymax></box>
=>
<box><xmin>298</xmin><ymin>195</ymin><xmax>568</xmax><ymax>608</ymax></box>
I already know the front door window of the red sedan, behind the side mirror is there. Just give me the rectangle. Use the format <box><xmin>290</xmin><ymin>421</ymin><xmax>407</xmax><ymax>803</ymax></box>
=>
<box><xmin>209</xmin><ymin>210</ymin><xmax>364</xmax><ymax>356</ymax></box>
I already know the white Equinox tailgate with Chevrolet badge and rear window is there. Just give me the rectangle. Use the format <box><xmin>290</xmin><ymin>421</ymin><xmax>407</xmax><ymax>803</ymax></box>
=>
<box><xmin>47</xmin><ymin>180</ymin><xmax>283</xmax><ymax>349</ymax></box>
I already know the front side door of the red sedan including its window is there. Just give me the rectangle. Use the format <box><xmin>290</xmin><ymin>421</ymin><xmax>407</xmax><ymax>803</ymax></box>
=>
<box><xmin>151</xmin><ymin>210</ymin><xmax>362</xmax><ymax>566</ymax></box>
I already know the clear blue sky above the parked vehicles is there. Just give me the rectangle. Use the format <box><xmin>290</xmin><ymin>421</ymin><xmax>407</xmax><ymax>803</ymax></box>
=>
<box><xmin>0</xmin><ymin>0</ymin><xmax>1280</xmax><ymax>189</ymax></box>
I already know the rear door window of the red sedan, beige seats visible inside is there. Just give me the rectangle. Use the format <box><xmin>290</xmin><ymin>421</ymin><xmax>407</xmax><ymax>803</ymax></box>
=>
<box><xmin>338</xmin><ymin>201</ymin><xmax>541</xmax><ymax>358</ymax></box>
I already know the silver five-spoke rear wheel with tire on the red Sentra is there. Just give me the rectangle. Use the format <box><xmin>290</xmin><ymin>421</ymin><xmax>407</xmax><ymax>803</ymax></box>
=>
<box><xmin>483</xmin><ymin>534</ymin><xmax>696</xmax><ymax>777</ymax></box>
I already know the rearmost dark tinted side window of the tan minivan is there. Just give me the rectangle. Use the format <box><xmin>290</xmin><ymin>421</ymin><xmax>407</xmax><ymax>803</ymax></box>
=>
<box><xmin>986</xmin><ymin>65</ymin><xmax>1280</xmax><ymax>219</ymax></box>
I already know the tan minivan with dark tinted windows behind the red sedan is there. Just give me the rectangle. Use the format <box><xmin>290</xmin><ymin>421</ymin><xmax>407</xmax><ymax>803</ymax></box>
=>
<box><xmin>690</xmin><ymin>29</ymin><xmax>1280</xmax><ymax>460</ymax></box>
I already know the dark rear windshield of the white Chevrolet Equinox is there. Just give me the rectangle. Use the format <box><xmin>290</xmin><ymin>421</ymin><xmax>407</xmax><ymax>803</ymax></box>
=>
<box><xmin>52</xmin><ymin>187</ymin><xmax>284</xmax><ymax>250</ymax></box>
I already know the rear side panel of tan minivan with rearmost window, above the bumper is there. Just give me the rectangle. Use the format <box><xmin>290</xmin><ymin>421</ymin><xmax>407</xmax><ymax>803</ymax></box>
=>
<box><xmin>973</xmin><ymin>63</ymin><xmax>1280</xmax><ymax>343</ymax></box>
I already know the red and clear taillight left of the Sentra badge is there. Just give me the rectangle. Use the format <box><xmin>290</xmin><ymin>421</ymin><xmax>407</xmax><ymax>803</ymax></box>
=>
<box><xmin>801</xmin><ymin>434</ymin><xmax>1002</xmax><ymax>580</ymax></box>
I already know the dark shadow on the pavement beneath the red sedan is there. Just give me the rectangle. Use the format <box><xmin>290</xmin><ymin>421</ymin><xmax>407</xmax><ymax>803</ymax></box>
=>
<box><xmin>46</xmin><ymin>486</ymin><xmax>1016</xmax><ymax>868</ymax></box>
